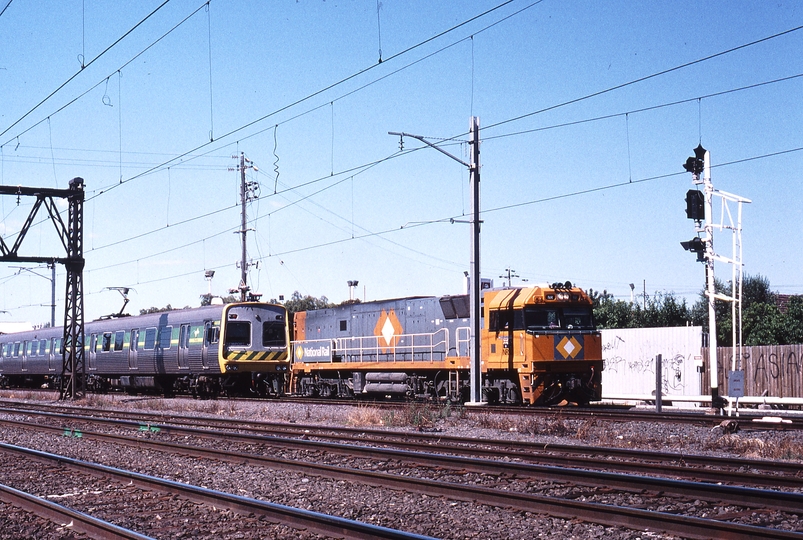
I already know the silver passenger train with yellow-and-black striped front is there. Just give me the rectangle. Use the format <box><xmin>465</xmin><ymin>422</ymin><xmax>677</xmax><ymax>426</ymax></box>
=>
<box><xmin>0</xmin><ymin>302</ymin><xmax>290</xmax><ymax>396</ymax></box>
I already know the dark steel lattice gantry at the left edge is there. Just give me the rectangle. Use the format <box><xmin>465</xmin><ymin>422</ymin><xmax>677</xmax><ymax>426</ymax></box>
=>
<box><xmin>0</xmin><ymin>178</ymin><xmax>86</xmax><ymax>399</ymax></box>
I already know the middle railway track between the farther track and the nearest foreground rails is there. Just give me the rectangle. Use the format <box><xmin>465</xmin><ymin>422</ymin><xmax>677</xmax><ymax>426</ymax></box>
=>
<box><xmin>1</xmin><ymin>404</ymin><xmax>803</xmax><ymax>538</ymax></box>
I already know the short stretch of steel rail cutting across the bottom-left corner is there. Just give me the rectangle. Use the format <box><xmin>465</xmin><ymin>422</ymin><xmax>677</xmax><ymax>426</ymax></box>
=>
<box><xmin>0</xmin><ymin>484</ymin><xmax>153</xmax><ymax>540</ymax></box>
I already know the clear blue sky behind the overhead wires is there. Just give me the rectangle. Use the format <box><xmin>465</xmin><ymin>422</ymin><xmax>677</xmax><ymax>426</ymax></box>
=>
<box><xmin>0</xmin><ymin>0</ymin><xmax>803</xmax><ymax>323</ymax></box>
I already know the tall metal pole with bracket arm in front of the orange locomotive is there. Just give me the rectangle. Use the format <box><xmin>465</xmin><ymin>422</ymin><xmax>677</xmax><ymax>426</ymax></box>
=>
<box><xmin>388</xmin><ymin>116</ymin><xmax>482</xmax><ymax>405</ymax></box>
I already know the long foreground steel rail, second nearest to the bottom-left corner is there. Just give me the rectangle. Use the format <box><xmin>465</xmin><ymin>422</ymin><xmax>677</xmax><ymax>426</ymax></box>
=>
<box><xmin>0</xmin><ymin>443</ymin><xmax>435</xmax><ymax>540</ymax></box>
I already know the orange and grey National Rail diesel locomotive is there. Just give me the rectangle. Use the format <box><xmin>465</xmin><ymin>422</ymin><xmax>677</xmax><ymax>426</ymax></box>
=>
<box><xmin>292</xmin><ymin>283</ymin><xmax>603</xmax><ymax>405</ymax></box>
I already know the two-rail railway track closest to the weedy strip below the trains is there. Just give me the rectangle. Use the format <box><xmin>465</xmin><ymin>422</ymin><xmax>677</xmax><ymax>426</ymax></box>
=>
<box><xmin>0</xmin><ymin>409</ymin><xmax>803</xmax><ymax>489</ymax></box>
